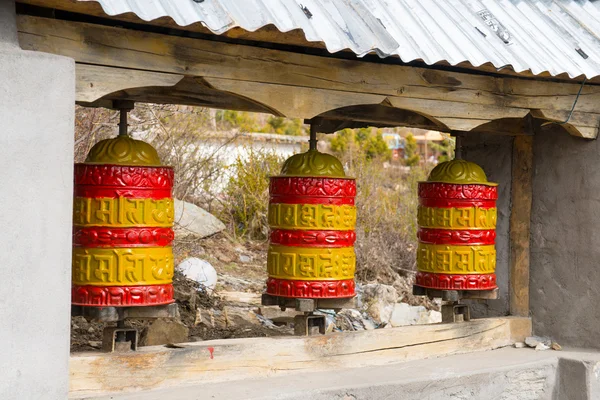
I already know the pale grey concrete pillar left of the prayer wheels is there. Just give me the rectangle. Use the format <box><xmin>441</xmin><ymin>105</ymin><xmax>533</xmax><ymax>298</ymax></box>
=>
<box><xmin>0</xmin><ymin>0</ymin><xmax>75</xmax><ymax>400</ymax></box>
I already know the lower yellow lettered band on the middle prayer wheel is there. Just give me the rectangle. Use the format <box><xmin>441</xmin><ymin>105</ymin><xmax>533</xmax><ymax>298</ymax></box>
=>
<box><xmin>267</xmin><ymin>245</ymin><xmax>356</xmax><ymax>281</ymax></box>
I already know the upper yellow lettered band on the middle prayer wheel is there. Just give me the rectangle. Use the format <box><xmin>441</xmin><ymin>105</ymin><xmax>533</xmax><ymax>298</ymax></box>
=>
<box><xmin>269</xmin><ymin>204</ymin><xmax>356</xmax><ymax>231</ymax></box>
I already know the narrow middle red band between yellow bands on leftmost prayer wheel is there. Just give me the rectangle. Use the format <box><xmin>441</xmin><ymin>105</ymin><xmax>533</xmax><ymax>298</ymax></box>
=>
<box><xmin>73</xmin><ymin>226</ymin><xmax>175</xmax><ymax>247</ymax></box>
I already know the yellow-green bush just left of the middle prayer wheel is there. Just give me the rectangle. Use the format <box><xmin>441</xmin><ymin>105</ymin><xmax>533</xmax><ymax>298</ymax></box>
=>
<box><xmin>221</xmin><ymin>147</ymin><xmax>285</xmax><ymax>240</ymax></box>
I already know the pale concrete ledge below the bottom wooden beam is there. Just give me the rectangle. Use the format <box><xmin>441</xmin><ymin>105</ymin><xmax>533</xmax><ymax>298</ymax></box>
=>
<box><xmin>78</xmin><ymin>348</ymin><xmax>600</xmax><ymax>400</ymax></box>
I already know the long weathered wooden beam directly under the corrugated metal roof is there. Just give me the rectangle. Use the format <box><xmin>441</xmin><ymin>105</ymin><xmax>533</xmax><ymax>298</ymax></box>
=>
<box><xmin>18</xmin><ymin>15</ymin><xmax>600</xmax><ymax>137</ymax></box>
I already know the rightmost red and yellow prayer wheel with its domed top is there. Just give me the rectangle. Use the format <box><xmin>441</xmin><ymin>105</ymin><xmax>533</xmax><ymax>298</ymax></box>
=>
<box><xmin>415</xmin><ymin>160</ymin><xmax>498</xmax><ymax>290</ymax></box>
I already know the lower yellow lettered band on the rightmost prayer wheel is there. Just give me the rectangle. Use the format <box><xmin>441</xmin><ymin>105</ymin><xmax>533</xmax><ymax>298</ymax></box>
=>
<box><xmin>417</xmin><ymin>243</ymin><xmax>496</xmax><ymax>275</ymax></box>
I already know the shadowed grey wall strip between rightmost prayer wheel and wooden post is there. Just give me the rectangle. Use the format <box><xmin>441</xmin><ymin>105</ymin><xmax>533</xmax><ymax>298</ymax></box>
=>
<box><xmin>463</xmin><ymin>134</ymin><xmax>513</xmax><ymax>317</ymax></box>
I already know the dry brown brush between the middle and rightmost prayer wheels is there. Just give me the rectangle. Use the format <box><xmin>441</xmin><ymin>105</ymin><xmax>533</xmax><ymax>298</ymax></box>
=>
<box><xmin>338</xmin><ymin>145</ymin><xmax>428</xmax><ymax>285</ymax></box>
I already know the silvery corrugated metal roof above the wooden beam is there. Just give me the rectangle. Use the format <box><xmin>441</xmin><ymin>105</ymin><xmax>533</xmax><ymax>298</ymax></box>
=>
<box><xmin>80</xmin><ymin>0</ymin><xmax>600</xmax><ymax>78</ymax></box>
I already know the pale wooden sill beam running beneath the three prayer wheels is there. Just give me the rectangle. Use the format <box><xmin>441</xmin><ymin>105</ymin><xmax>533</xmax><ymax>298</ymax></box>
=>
<box><xmin>69</xmin><ymin>317</ymin><xmax>531</xmax><ymax>398</ymax></box>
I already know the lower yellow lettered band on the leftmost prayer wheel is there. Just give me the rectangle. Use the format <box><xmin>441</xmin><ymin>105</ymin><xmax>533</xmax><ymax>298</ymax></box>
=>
<box><xmin>72</xmin><ymin>247</ymin><xmax>173</xmax><ymax>286</ymax></box>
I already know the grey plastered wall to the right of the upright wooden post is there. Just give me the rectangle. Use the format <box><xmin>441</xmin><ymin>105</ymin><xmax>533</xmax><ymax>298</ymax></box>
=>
<box><xmin>530</xmin><ymin>125</ymin><xmax>600</xmax><ymax>348</ymax></box>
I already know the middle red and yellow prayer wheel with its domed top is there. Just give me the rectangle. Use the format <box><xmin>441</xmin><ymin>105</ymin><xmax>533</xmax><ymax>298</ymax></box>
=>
<box><xmin>267</xmin><ymin>150</ymin><xmax>356</xmax><ymax>299</ymax></box>
